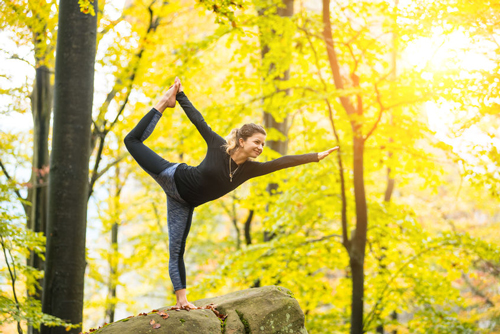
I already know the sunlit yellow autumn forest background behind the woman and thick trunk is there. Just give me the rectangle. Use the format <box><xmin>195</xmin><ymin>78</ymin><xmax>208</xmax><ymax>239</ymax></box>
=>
<box><xmin>0</xmin><ymin>0</ymin><xmax>500</xmax><ymax>333</ymax></box>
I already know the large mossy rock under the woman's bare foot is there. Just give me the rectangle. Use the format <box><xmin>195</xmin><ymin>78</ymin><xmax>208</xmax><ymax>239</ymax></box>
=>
<box><xmin>92</xmin><ymin>286</ymin><xmax>307</xmax><ymax>334</ymax></box>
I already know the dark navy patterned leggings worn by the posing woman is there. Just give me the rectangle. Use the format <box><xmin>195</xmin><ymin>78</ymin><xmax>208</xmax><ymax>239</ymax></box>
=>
<box><xmin>125</xmin><ymin>109</ymin><xmax>194</xmax><ymax>291</ymax></box>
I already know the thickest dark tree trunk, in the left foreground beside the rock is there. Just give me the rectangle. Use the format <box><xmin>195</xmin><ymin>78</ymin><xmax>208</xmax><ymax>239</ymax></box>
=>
<box><xmin>42</xmin><ymin>1</ymin><xmax>98</xmax><ymax>334</ymax></box>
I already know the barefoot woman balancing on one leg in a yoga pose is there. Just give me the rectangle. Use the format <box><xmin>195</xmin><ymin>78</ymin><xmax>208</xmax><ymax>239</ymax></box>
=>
<box><xmin>125</xmin><ymin>78</ymin><xmax>338</xmax><ymax>308</ymax></box>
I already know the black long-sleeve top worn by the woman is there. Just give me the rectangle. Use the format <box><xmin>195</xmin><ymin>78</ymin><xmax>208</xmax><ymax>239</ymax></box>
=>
<box><xmin>174</xmin><ymin>92</ymin><xmax>319</xmax><ymax>206</ymax></box>
